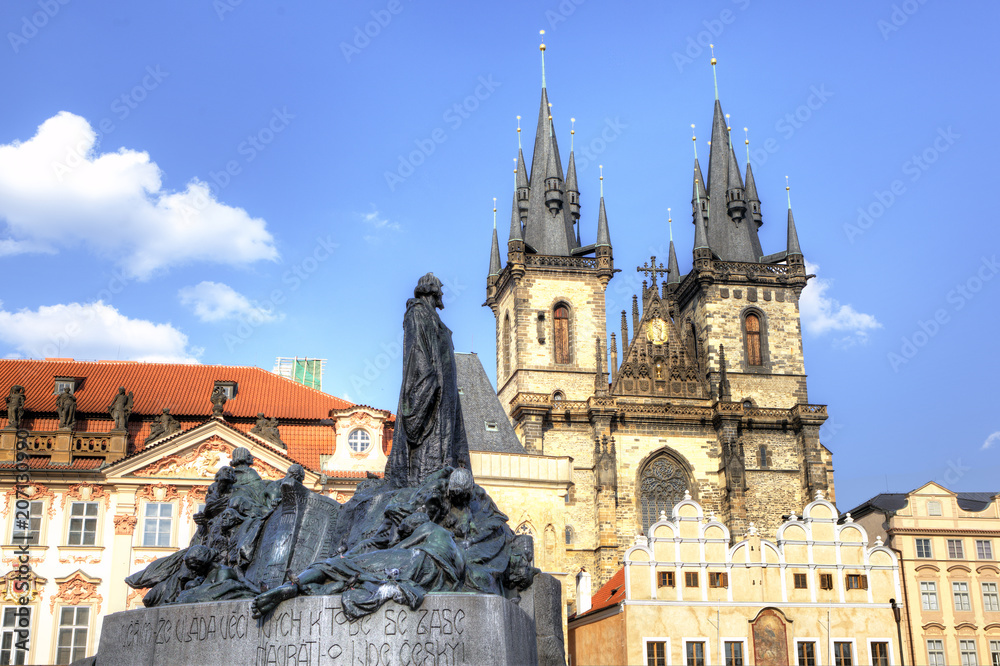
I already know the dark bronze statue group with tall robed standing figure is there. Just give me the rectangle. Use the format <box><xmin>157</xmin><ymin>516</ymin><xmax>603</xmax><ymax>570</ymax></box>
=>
<box><xmin>126</xmin><ymin>273</ymin><xmax>539</xmax><ymax>619</ymax></box>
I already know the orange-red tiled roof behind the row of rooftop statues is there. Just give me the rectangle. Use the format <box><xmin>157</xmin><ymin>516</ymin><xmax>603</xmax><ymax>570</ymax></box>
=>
<box><xmin>0</xmin><ymin>359</ymin><xmax>352</xmax><ymax>425</ymax></box>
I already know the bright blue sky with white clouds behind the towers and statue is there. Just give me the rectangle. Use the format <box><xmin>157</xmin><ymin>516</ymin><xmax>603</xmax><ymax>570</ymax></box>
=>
<box><xmin>0</xmin><ymin>0</ymin><xmax>1000</xmax><ymax>509</ymax></box>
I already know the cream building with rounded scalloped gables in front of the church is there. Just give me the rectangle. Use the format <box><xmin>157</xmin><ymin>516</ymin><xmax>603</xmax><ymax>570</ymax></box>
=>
<box><xmin>568</xmin><ymin>495</ymin><xmax>912</xmax><ymax>666</ymax></box>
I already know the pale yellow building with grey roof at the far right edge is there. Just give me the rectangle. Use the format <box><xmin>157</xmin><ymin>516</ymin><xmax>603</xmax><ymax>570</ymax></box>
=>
<box><xmin>851</xmin><ymin>482</ymin><xmax>1000</xmax><ymax>666</ymax></box>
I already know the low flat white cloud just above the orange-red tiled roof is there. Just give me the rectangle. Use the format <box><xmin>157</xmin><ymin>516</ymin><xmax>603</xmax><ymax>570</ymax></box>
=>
<box><xmin>0</xmin><ymin>301</ymin><xmax>201</xmax><ymax>363</ymax></box>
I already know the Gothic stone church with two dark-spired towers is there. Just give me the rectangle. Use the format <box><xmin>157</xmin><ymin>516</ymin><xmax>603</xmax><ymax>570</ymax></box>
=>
<box><xmin>485</xmin><ymin>67</ymin><xmax>835</xmax><ymax>598</ymax></box>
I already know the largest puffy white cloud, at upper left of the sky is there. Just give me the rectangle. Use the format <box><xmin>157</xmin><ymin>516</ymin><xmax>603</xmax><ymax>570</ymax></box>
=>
<box><xmin>0</xmin><ymin>111</ymin><xmax>278</xmax><ymax>280</ymax></box>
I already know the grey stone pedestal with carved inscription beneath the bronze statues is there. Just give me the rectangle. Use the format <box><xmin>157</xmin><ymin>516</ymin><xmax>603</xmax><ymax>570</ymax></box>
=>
<box><xmin>96</xmin><ymin>594</ymin><xmax>537</xmax><ymax>666</ymax></box>
